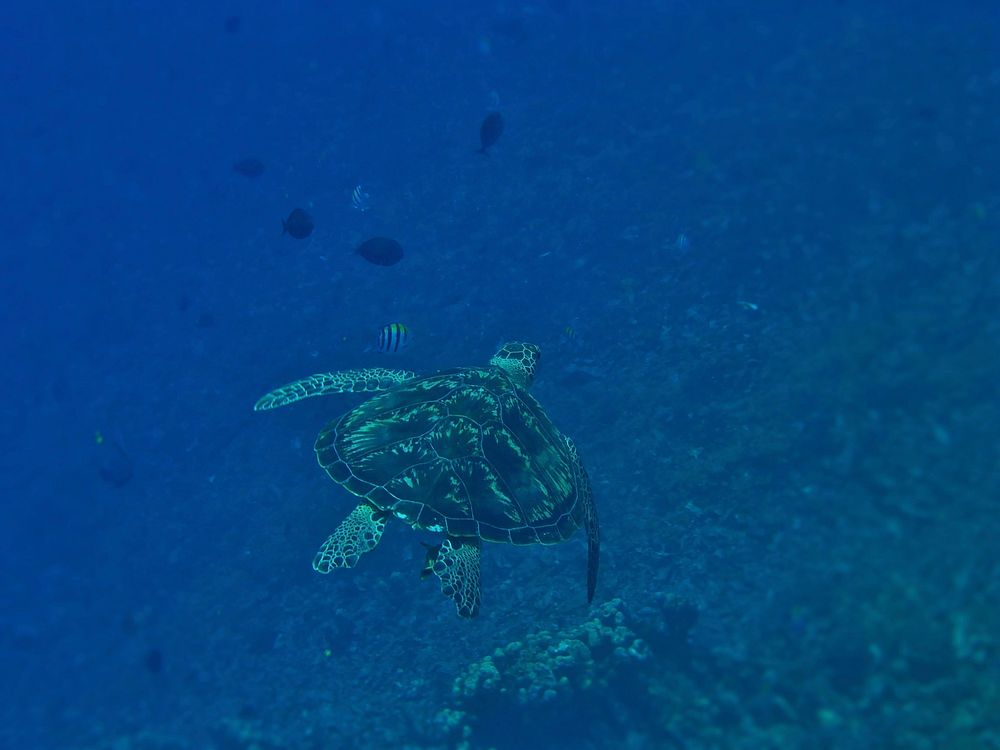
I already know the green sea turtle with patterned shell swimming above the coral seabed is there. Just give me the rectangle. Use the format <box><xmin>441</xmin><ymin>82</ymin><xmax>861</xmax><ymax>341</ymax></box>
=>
<box><xmin>254</xmin><ymin>343</ymin><xmax>600</xmax><ymax>617</ymax></box>
